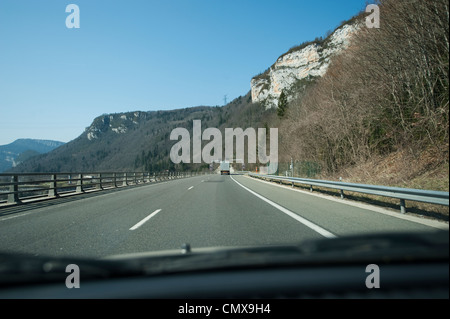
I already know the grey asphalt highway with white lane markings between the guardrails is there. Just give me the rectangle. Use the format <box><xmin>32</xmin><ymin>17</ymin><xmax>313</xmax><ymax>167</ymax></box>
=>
<box><xmin>0</xmin><ymin>175</ymin><xmax>448</xmax><ymax>258</ymax></box>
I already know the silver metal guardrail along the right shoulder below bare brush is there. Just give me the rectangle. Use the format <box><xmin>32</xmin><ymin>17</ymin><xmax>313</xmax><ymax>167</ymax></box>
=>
<box><xmin>248</xmin><ymin>173</ymin><xmax>449</xmax><ymax>214</ymax></box>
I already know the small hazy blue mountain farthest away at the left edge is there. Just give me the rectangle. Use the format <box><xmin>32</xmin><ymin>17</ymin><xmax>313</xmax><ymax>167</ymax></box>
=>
<box><xmin>0</xmin><ymin>138</ymin><xmax>64</xmax><ymax>172</ymax></box>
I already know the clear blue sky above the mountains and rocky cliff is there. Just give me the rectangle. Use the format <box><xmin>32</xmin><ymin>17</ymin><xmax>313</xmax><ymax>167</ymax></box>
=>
<box><xmin>0</xmin><ymin>0</ymin><xmax>366</xmax><ymax>145</ymax></box>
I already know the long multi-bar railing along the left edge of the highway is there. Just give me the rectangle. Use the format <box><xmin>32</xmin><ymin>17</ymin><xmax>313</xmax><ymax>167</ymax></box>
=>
<box><xmin>0</xmin><ymin>172</ymin><xmax>209</xmax><ymax>205</ymax></box>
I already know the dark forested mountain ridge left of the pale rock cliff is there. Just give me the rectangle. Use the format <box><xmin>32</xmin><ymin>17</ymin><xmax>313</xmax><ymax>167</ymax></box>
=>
<box><xmin>12</xmin><ymin>92</ymin><xmax>275</xmax><ymax>172</ymax></box>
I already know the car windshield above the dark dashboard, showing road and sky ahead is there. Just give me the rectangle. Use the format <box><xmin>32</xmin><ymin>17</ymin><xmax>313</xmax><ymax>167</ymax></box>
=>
<box><xmin>0</xmin><ymin>0</ymin><xmax>449</xmax><ymax>296</ymax></box>
